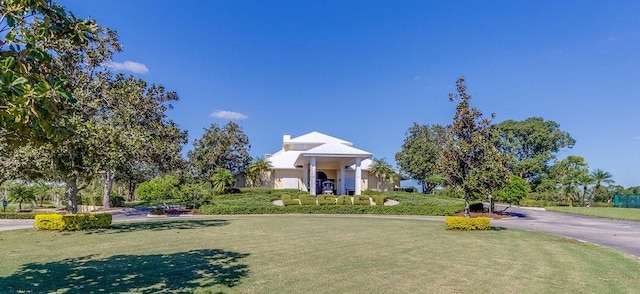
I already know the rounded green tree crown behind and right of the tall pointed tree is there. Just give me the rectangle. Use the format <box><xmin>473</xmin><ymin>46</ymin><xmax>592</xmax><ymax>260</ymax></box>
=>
<box><xmin>493</xmin><ymin>117</ymin><xmax>575</xmax><ymax>182</ymax></box>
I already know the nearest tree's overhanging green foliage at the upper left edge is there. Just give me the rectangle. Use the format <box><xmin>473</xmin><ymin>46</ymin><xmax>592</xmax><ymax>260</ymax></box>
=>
<box><xmin>0</xmin><ymin>0</ymin><xmax>98</xmax><ymax>148</ymax></box>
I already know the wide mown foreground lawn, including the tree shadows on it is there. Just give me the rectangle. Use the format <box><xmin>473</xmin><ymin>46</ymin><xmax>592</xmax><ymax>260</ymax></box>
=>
<box><xmin>0</xmin><ymin>215</ymin><xmax>640</xmax><ymax>293</ymax></box>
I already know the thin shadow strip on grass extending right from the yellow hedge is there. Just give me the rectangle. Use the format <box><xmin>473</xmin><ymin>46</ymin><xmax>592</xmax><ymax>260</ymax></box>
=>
<box><xmin>105</xmin><ymin>219</ymin><xmax>229</xmax><ymax>234</ymax></box>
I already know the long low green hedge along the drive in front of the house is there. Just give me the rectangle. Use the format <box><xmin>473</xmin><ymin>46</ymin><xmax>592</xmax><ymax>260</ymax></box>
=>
<box><xmin>200</xmin><ymin>204</ymin><xmax>464</xmax><ymax>215</ymax></box>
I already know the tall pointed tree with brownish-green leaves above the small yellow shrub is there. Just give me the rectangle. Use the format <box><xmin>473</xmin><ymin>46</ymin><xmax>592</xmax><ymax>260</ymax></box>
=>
<box><xmin>437</xmin><ymin>77</ymin><xmax>508</xmax><ymax>217</ymax></box>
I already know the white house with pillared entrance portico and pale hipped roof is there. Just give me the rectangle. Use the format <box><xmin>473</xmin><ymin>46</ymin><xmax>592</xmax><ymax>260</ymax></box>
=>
<box><xmin>266</xmin><ymin>132</ymin><xmax>393</xmax><ymax>195</ymax></box>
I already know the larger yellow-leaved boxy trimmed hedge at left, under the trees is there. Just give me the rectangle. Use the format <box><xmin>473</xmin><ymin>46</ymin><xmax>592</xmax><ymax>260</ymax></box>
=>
<box><xmin>35</xmin><ymin>213</ymin><xmax>112</xmax><ymax>231</ymax></box>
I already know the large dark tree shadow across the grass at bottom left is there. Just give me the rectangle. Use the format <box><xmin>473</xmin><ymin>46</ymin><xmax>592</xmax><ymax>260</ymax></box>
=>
<box><xmin>0</xmin><ymin>249</ymin><xmax>249</xmax><ymax>293</ymax></box>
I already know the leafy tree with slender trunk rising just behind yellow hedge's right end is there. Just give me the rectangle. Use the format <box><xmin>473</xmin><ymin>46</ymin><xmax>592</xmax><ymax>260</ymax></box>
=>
<box><xmin>92</xmin><ymin>75</ymin><xmax>187</xmax><ymax>208</ymax></box>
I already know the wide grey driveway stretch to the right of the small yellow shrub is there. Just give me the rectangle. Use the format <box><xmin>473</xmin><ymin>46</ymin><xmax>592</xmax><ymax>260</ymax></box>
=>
<box><xmin>491</xmin><ymin>207</ymin><xmax>640</xmax><ymax>258</ymax></box>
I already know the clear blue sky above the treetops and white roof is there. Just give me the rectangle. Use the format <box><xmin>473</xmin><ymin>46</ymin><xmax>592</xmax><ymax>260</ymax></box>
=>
<box><xmin>59</xmin><ymin>0</ymin><xmax>640</xmax><ymax>186</ymax></box>
